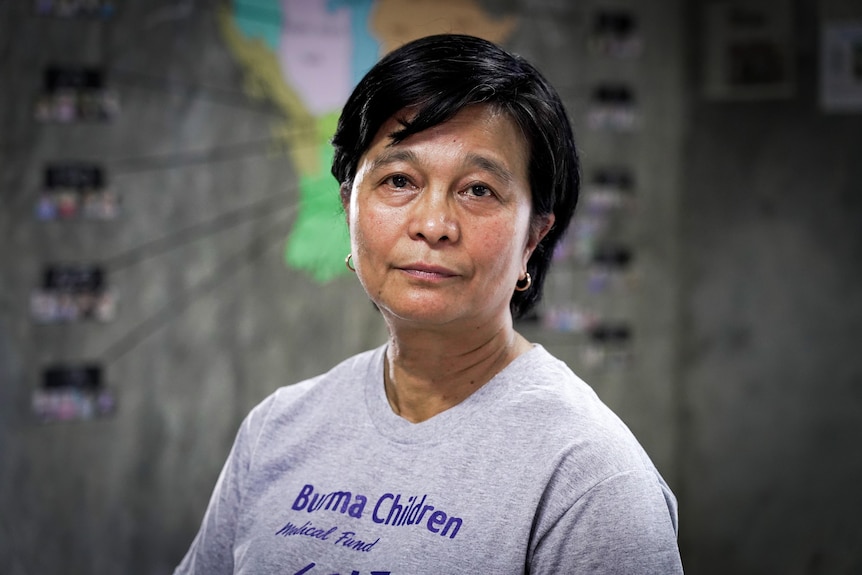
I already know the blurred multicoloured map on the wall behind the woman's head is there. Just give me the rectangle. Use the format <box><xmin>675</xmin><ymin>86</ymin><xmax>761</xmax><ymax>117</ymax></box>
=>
<box><xmin>220</xmin><ymin>0</ymin><xmax>517</xmax><ymax>282</ymax></box>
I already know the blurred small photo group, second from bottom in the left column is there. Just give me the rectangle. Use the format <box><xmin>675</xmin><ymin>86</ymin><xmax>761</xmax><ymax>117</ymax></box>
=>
<box><xmin>30</xmin><ymin>265</ymin><xmax>117</xmax><ymax>323</ymax></box>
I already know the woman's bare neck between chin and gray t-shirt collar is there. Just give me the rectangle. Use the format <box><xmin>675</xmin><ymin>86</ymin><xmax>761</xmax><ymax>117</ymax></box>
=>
<box><xmin>384</xmin><ymin>320</ymin><xmax>530</xmax><ymax>423</ymax></box>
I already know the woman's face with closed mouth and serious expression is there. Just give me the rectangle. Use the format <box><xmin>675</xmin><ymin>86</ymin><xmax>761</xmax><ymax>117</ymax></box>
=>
<box><xmin>345</xmin><ymin>105</ymin><xmax>553</xmax><ymax>327</ymax></box>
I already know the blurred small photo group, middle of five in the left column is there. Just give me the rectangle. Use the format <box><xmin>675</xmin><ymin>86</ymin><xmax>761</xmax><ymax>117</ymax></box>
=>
<box><xmin>35</xmin><ymin>163</ymin><xmax>120</xmax><ymax>221</ymax></box>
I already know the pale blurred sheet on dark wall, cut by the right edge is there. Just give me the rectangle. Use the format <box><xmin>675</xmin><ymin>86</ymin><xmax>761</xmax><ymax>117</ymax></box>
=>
<box><xmin>820</xmin><ymin>20</ymin><xmax>862</xmax><ymax>113</ymax></box>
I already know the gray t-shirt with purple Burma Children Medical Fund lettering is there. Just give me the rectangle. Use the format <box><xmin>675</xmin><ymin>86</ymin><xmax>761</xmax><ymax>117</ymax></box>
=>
<box><xmin>175</xmin><ymin>345</ymin><xmax>682</xmax><ymax>575</ymax></box>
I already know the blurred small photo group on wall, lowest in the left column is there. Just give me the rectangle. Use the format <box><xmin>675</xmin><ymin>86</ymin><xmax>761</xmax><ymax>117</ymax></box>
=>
<box><xmin>31</xmin><ymin>364</ymin><xmax>117</xmax><ymax>423</ymax></box>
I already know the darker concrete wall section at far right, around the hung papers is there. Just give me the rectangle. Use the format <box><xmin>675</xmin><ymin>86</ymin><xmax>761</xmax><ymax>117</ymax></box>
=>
<box><xmin>678</xmin><ymin>1</ymin><xmax>862</xmax><ymax>575</ymax></box>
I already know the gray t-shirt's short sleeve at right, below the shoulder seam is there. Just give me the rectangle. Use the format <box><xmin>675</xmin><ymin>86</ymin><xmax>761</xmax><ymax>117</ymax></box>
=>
<box><xmin>528</xmin><ymin>470</ymin><xmax>683</xmax><ymax>575</ymax></box>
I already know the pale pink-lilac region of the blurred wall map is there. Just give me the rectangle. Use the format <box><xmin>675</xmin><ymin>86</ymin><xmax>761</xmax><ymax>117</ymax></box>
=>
<box><xmin>279</xmin><ymin>0</ymin><xmax>353</xmax><ymax>116</ymax></box>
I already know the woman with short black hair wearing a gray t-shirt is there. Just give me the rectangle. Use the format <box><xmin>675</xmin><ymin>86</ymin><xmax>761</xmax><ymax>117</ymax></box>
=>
<box><xmin>176</xmin><ymin>35</ymin><xmax>682</xmax><ymax>575</ymax></box>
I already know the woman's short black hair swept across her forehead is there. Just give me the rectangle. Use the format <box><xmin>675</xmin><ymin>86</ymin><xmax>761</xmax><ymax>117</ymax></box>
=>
<box><xmin>332</xmin><ymin>34</ymin><xmax>580</xmax><ymax>318</ymax></box>
